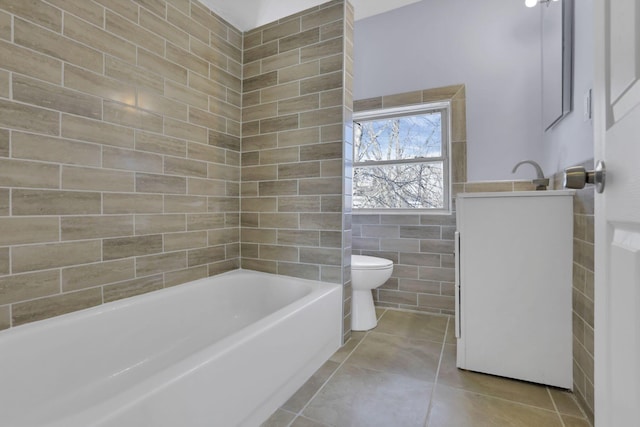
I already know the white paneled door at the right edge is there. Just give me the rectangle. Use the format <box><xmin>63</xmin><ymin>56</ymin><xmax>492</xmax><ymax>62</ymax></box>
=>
<box><xmin>594</xmin><ymin>0</ymin><xmax>640</xmax><ymax>427</ymax></box>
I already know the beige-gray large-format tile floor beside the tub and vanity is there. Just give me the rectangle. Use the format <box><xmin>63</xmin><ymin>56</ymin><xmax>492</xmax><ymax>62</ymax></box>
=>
<box><xmin>262</xmin><ymin>309</ymin><xmax>590</xmax><ymax>427</ymax></box>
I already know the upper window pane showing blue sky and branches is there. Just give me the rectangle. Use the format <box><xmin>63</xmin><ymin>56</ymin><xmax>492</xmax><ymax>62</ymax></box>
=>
<box><xmin>354</xmin><ymin>111</ymin><xmax>442</xmax><ymax>163</ymax></box>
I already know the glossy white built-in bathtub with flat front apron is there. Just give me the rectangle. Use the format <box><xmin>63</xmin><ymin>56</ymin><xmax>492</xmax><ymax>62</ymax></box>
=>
<box><xmin>0</xmin><ymin>270</ymin><xmax>342</xmax><ymax>427</ymax></box>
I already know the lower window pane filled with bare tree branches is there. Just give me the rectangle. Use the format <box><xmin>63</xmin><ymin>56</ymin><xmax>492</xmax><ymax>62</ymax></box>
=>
<box><xmin>353</xmin><ymin>162</ymin><xmax>444</xmax><ymax>209</ymax></box>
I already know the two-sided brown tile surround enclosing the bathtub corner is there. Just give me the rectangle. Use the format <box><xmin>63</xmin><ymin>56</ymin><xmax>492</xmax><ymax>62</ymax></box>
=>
<box><xmin>0</xmin><ymin>0</ymin><xmax>353</xmax><ymax>329</ymax></box>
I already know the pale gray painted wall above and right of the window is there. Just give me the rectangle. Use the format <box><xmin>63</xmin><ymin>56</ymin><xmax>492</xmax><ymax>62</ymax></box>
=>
<box><xmin>354</xmin><ymin>0</ymin><xmax>552</xmax><ymax>181</ymax></box>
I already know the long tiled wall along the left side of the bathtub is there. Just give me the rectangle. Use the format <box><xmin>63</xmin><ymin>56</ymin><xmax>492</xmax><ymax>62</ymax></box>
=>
<box><xmin>0</xmin><ymin>0</ymin><xmax>242</xmax><ymax>329</ymax></box>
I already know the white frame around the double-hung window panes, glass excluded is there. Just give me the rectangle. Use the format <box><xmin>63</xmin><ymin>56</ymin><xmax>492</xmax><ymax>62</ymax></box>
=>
<box><xmin>353</xmin><ymin>101</ymin><xmax>452</xmax><ymax>215</ymax></box>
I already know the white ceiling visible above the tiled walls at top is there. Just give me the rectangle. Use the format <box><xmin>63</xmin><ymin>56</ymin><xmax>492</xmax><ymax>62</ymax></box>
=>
<box><xmin>200</xmin><ymin>0</ymin><xmax>420</xmax><ymax>31</ymax></box>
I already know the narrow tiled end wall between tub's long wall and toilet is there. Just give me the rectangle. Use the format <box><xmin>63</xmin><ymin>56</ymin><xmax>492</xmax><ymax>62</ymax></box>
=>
<box><xmin>241</xmin><ymin>0</ymin><xmax>353</xmax><ymax>338</ymax></box>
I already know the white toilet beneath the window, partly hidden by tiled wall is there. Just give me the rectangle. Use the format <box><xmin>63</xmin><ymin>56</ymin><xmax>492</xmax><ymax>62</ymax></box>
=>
<box><xmin>351</xmin><ymin>255</ymin><xmax>393</xmax><ymax>331</ymax></box>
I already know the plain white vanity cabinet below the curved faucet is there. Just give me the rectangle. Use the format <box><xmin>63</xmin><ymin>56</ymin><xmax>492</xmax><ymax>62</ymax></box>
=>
<box><xmin>456</xmin><ymin>190</ymin><xmax>574</xmax><ymax>389</ymax></box>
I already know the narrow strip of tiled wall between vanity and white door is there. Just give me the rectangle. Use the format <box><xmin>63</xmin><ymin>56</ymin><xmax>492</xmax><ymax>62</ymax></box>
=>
<box><xmin>554</xmin><ymin>164</ymin><xmax>595</xmax><ymax>423</ymax></box>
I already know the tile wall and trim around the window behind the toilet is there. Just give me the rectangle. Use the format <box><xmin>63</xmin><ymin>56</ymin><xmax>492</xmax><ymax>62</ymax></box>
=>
<box><xmin>352</xmin><ymin>85</ymin><xmax>467</xmax><ymax>314</ymax></box>
